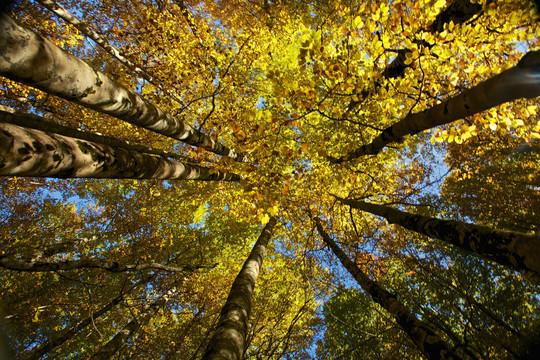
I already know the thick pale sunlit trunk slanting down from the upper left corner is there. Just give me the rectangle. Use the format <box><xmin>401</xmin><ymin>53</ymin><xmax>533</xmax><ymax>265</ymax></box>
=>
<box><xmin>0</xmin><ymin>14</ymin><xmax>243</xmax><ymax>161</ymax></box>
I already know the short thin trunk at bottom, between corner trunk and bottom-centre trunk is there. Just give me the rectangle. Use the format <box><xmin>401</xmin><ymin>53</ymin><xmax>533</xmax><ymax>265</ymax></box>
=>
<box><xmin>92</xmin><ymin>293</ymin><xmax>171</xmax><ymax>360</ymax></box>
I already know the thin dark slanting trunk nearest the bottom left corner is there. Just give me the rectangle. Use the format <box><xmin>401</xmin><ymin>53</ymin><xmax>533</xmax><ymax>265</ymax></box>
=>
<box><xmin>17</xmin><ymin>275</ymin><xmax>154</xmax><ymax>360</ymax></box>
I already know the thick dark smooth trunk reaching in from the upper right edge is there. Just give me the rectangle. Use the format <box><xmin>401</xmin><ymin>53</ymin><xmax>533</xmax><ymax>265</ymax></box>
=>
<box><xmin>328</xmin><ymin>51</ymin><xmax>540</xmax><ymax>164</ymax></box>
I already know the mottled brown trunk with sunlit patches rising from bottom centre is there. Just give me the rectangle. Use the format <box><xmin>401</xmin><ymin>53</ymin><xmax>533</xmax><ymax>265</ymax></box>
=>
<box><xmin>203</xmin><ymin>217</ymin><xmax>277</xmax><ymax>360</ymax></box>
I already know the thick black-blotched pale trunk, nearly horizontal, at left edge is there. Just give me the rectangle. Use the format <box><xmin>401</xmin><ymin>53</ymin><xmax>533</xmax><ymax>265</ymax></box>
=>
<box><xmin>0</xmin><ymin>123</ymin><xmax>240</xmax><ymax>181</ymax></box>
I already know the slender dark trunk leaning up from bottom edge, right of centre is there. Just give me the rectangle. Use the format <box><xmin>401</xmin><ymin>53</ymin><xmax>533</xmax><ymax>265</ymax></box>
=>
<box><xmin>315</xmin><ymin>218</ymin><xmax>460</xmax><ymax>360</ymax></box>
